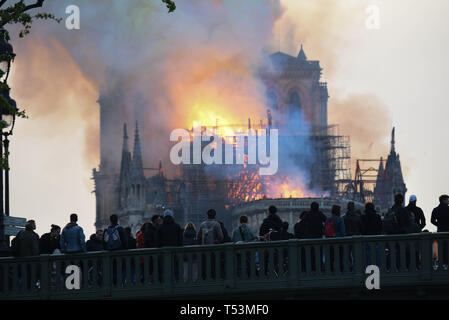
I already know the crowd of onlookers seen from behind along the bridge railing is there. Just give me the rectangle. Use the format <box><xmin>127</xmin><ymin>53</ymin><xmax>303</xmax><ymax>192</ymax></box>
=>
<box><xmin>12</xmin><ymin>194</ymin><xmax>449</xmax><ymax>257</ymax></box>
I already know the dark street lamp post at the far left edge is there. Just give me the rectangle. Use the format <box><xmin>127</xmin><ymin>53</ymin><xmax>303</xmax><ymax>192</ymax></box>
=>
<box><xmin>0</xmin><ymin>28</ymin><xmax>17</xmax><ymax>255</ymax></box>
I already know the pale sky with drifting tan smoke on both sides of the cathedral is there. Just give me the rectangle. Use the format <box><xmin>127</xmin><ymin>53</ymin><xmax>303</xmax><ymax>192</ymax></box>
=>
<box><xmin>4</xmin><ymin>0</ymin><xmax>449</xmax><ymax>236</ymax></box>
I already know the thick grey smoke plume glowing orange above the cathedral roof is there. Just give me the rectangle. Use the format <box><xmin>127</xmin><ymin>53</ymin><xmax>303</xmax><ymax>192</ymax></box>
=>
<box><xmin>16</xmin><ymin>0</ymin><xmax>281</xmax><ymax>176</ymax></box>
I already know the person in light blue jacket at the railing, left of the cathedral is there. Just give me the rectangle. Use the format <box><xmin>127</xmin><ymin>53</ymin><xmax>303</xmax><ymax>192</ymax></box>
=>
<box><xmin>59</xmin><ymin>213</ymin><xmax>86</xmax><ymax>253</ymax></box>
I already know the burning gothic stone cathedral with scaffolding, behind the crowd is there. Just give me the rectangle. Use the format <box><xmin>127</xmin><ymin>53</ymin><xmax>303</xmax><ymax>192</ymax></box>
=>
<box><xmin>93</xmin><ymin>46</ymin><xmax>406</xmax><ymax>233</ymax></box>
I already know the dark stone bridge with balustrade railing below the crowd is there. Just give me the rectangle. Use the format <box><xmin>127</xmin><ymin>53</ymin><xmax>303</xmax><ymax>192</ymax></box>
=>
<box><xmin>0</xmin><ymin>233</ymin><xmax>449</xmax><ymax>300</ymax></box>
